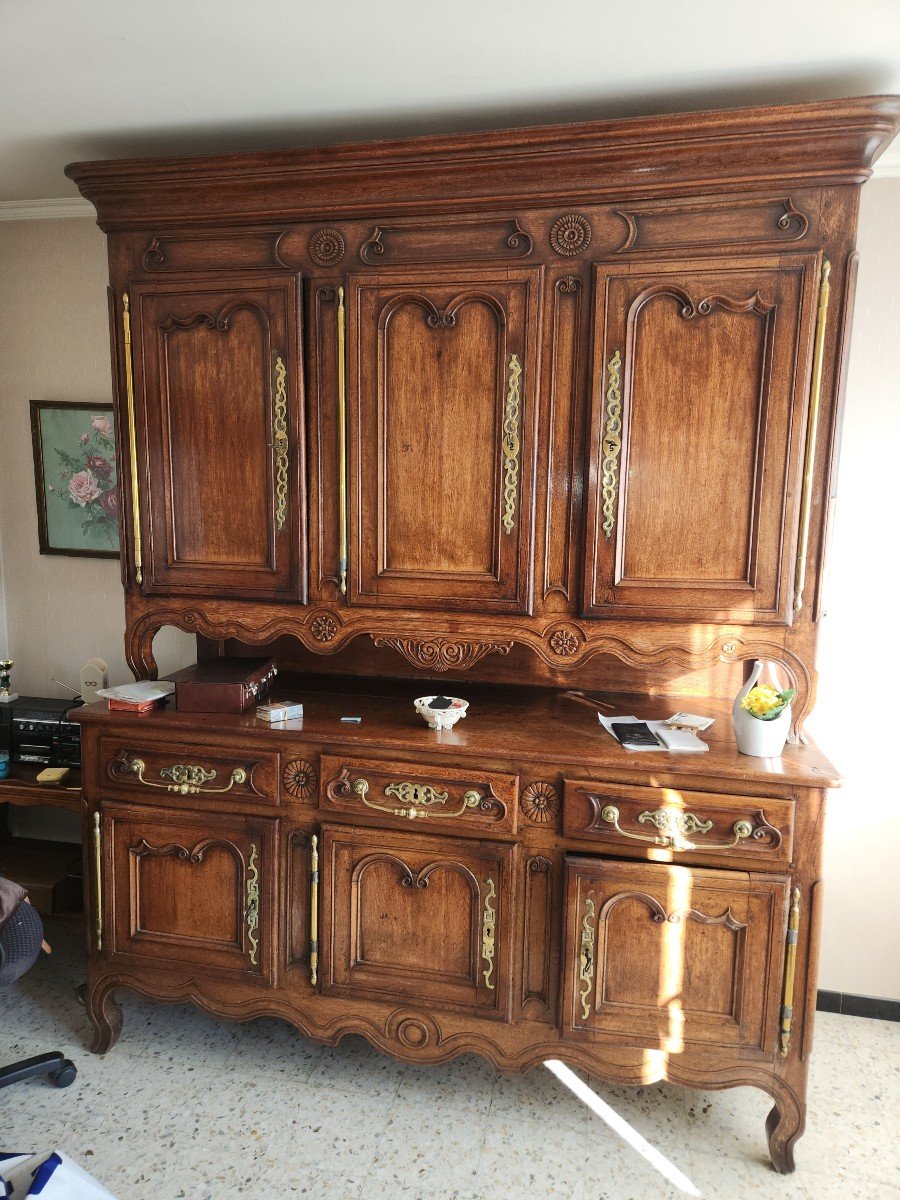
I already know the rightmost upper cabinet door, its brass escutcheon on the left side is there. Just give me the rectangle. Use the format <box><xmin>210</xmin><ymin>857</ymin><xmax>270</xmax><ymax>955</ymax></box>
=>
<box><xmin>583</xmin><ymin>254</ymin><xmax>818</xmax><ymax>624</ymax></box>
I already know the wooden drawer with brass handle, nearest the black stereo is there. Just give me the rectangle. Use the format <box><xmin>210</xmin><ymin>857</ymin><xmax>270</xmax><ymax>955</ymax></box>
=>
<box><xmin>100</xmin><ymin>738</ymin><xmax>278</xmax><ymax>809</ymax></box>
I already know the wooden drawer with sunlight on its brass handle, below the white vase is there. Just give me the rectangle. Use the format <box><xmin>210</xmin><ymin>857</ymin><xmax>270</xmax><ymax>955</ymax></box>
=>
<box><xmin>563</xmin><ymin>779</ymin><xmax>794</xmax><ymax>866</ymax></box>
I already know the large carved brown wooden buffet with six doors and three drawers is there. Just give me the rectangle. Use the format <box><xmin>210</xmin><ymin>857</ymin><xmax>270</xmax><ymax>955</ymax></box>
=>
<box><xmin>68</xmin><ymin>97</ymin><xmax>900</xmax><ymax>1171</ymax></box>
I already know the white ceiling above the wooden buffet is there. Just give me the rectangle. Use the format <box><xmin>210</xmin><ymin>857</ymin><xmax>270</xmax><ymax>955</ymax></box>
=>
<box><xmin>0</xmin><ymin>0</ymin><xmax>900</xmax><ymax>206</ymax></box>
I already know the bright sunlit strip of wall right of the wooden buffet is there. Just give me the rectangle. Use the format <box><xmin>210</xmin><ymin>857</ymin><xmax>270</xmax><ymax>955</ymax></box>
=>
<box><xmin>810</xmin><ymin>179</ymin><xmax>900</xmax><ymax>998</ymax></box>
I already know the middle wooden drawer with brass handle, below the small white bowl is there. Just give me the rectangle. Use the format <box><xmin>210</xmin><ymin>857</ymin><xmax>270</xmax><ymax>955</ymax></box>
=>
<box><xmin>322</xmin><ymin>755</ymin><xmax>518</xmax><ymax>834</ymax></box>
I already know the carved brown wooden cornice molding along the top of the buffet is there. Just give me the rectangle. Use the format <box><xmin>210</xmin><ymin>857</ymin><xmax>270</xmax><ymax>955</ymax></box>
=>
<box><xmin>66</xmin><ymin>96</ymin><xmax>900</xmax><ymax>229</ymax></box>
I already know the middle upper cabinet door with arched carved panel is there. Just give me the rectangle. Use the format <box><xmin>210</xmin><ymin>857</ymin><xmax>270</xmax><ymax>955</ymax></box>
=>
<box><xmin>348</xmin><ymin>268</ymin><xmax>541</xmax><ymax>613</ymax></box>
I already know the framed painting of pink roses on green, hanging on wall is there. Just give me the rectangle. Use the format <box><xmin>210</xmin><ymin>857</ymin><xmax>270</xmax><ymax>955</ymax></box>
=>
<box><xmin>31</xmin><ymin>400</ymin><xmax>119</xmax><ymax>558</ymax></box>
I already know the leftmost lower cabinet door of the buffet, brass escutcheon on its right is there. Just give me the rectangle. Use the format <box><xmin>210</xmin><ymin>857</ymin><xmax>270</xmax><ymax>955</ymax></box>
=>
<box><xmin>102</xmin><ymin>805</ymin><xmax>277</xmax><ymax>983</ymax></box>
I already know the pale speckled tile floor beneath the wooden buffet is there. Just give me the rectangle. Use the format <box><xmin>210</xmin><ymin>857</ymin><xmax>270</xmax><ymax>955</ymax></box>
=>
<box><xmin>0</xmin><ymin>924</ymin><xmax>900</xmax><ymax>1200</ymax></box>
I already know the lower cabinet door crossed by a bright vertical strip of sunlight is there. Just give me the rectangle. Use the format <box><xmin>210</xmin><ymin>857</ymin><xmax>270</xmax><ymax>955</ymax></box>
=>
<box><xmin>563</xmin><ymin>856</ymin><xmax>790</xmax><ymax>1056</ymax></box>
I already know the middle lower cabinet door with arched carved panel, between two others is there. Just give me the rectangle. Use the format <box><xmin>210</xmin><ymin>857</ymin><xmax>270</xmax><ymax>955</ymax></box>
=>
<box><xmin>320</xmin><ymin>827</ymin><xmax>512</xmax><ymax>1019</ymax></box>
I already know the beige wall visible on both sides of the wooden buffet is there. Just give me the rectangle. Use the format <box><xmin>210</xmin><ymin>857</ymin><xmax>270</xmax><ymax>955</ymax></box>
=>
<box><xmin>0</xmin><ymin>180</ymin><xmax>900</xmax><ymax>998</ymax></box>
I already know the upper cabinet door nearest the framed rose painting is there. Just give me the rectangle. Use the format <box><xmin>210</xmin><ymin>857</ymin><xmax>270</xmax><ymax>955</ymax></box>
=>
<box><xmin>131</xmin><ymin>275</ymin><xmax>306</xmax><ymax>599</ymax></box>
